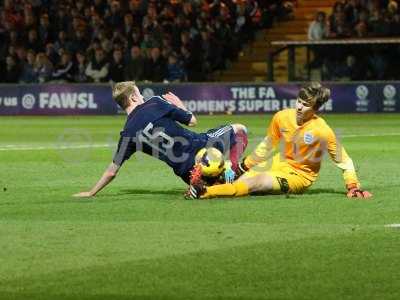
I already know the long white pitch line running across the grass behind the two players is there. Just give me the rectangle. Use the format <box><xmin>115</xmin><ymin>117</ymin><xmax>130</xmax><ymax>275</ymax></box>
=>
<box><xmin>0</xmin><ymin>133</ymin><xmax>400</xmax><ymax>151</ymax></box>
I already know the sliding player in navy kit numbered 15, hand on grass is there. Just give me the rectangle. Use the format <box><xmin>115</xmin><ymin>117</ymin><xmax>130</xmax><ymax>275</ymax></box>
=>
<box><xmin>74</xmin><ymin>81</ymin><xmax>247</xmax><ymax>197</ymax></box>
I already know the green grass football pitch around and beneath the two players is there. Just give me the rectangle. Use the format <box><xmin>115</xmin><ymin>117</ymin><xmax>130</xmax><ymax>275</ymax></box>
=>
<box><xmin>0</xmin><ymin>114</ymin><xmax>400</xmax><ymax>300</ymax></box>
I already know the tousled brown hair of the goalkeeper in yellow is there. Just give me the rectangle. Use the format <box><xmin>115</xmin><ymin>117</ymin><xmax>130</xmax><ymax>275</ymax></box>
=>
<box><xmin>299</xmin><ymin>81</ymin><xmax>331</xmax><ymax>110</ymax></box>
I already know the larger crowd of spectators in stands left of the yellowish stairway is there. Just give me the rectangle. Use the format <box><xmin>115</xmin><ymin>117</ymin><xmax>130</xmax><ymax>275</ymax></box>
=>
<box><xmin>0</xmin><ymin>0</ymin><xmax>289</xmax><ymax>83</ymax></box>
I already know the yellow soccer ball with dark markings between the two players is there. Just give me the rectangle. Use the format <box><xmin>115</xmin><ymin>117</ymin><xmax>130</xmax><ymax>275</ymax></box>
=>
<box><xmin>195</xmin><ymin>147</ymin><xmax>225</xmax><ymax>177</ymax></box>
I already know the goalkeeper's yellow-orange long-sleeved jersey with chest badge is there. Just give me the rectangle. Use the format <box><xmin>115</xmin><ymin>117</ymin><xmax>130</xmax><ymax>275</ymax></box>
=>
<box><xmin>245</xmin><ymin>109</ymin><xmax>359</xmax><ymax>186</ymax></box>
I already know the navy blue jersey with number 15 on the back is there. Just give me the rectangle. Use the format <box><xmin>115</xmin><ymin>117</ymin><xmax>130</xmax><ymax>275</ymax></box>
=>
<box><xmin>113</xmin><ymin>96</ymin><xmax>208</xmax><ymax>177</ymax></box>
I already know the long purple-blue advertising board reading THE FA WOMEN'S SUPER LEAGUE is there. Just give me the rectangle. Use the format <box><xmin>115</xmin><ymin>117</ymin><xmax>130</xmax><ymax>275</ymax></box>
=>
<box><xmin>0</xmin><ymin>82</ymin><xmax>400</xmax><ymax>115</ymax></box>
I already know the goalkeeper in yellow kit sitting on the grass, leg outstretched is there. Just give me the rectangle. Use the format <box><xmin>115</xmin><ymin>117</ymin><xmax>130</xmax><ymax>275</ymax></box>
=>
<box><xmin>190</xmin><ymin>82</ymin><xmax>372</xmax><ymax>198</ymax></box>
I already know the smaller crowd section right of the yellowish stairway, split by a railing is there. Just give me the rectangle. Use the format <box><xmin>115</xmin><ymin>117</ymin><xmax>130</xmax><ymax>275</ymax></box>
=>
<box><xmin>308</xmin><ymin>0</ymin><xmax>400</xmax><ymax>80</ymax></box>
